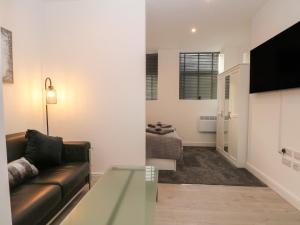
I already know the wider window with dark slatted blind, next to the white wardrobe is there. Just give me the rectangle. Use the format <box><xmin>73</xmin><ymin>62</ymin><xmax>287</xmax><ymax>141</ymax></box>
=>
<box><xmin>179</xmin><ymin>52</ymin><xmax>219</xmax><ymax>99</ymax></box>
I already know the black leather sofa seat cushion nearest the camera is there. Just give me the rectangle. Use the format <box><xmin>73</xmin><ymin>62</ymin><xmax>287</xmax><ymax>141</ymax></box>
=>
<box><xmin>11</xmin><ymin>184</ymin><xmax>62</xmax><ymax>225</ymax></box>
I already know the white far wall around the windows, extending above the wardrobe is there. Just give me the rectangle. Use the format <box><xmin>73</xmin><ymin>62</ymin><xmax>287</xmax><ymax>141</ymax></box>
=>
<box><xmin>146</xmin><ymin>26</ymin><xmax>250</xmax><ymax>146</ymax></box>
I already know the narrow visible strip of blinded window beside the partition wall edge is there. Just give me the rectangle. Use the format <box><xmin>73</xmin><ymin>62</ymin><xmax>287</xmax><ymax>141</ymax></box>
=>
<box><xmin>146</xmin><ymin>54</ymin><xmax>158</xmax><ymax>100</ymax></box>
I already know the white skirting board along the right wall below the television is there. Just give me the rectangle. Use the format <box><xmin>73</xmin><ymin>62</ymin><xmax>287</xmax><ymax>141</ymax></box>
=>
<box><xmin>246</xmin><ymin>163</ymin><xmax>300</xmax><ymax>210</ymax></box>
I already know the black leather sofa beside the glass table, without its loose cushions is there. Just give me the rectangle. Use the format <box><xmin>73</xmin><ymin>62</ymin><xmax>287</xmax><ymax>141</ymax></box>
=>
<box><xmin>6</xmin><ymin>133</ymin><xmax>90</xmax><ymax>225</ymax></box>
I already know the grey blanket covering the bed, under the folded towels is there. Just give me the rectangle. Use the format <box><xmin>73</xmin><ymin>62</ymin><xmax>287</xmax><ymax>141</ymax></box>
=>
<box><xmin>146</xmin><ymin>131</ymin><xmax>183</xmax><ymax>160</ymax></box>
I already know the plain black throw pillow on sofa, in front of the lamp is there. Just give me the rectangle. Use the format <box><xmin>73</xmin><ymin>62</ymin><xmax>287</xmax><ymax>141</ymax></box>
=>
<box><xmin>25</xmin><ymin>130</ymin><xmax>63</xmax><ymax>168</ymax></box>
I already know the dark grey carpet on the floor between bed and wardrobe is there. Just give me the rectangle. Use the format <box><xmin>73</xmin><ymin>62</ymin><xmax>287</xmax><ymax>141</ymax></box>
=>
<box><xmin>159</xmin><ymin>147</ymin><xmax>266</xmax><ymax>187</ymax></box>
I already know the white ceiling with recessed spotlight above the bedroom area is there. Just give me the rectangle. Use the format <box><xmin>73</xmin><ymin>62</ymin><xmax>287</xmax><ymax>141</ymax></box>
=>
<box><xmin>146</xmin><ymin>0</ymin><xmax>267</xmax><ymax>50</ymax></box>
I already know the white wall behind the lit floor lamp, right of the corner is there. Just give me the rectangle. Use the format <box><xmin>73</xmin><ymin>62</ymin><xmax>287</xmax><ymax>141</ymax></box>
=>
<box><xmin>43</xmin><ymin>0</ymin><xmax>145</xmax><ymax>172</ymax></box>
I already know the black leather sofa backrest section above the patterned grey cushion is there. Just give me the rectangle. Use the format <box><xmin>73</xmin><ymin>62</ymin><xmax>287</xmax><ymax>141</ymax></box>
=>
<box><xmin>6</xmin><ymin>133</ymin><xmax>27</xmax><ymax>162</ymax></box>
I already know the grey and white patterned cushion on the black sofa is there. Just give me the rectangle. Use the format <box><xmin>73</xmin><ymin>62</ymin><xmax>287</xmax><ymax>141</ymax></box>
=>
<box><xmin>7</xmin><ymin>157</ymin><xmax>39</xmax><ymax>189</ymax></box>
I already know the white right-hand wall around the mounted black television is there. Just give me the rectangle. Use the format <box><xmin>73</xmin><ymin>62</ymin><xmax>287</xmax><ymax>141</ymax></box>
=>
<box><xmin>248</xmin><ymin>0</ymin><xmax>300</xmax><ymax>209</ymax></box>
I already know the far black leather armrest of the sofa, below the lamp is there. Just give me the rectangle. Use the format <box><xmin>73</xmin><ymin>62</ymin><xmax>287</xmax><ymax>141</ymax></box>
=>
<box><xmin>63</xmin><ymin>141</ymin><xmax>91</xmax><ymax>162</ymax></box>
